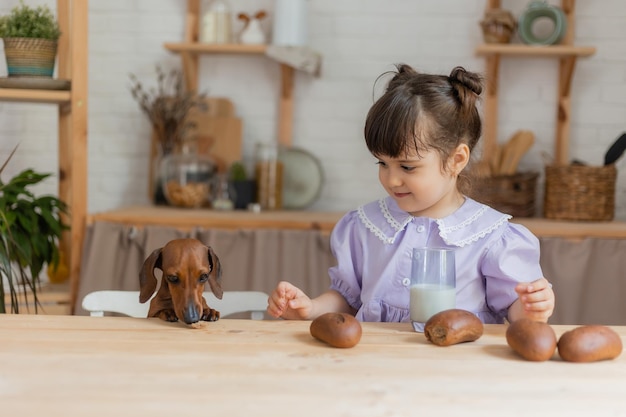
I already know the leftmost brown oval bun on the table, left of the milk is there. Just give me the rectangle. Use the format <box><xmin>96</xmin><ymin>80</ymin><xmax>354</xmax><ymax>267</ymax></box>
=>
<box><xmin>309</xmin><ymin>313</ymin><xmax>362</xmax><ymax>348</ymax></box>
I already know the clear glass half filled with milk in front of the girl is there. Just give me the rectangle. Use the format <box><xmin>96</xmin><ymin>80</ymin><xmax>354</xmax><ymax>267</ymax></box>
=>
<box><xmin>409</xmin><ymin>247</ymin><xmax>456</xmax><ymax>332</ymax></box>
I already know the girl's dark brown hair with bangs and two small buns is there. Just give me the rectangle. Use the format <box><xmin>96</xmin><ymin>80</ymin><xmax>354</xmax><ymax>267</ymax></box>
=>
<box><xmin>365</xmin><ymin>64</ymin><xmax>483</xmax><ymax>182</ymax></box>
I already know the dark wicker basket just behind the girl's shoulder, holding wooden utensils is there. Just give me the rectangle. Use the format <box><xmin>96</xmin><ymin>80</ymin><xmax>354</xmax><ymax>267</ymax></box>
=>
<box><xmin>469</xmin><ymin>172</ymin><xmax>539</xmax><ymax>217</ymax></box>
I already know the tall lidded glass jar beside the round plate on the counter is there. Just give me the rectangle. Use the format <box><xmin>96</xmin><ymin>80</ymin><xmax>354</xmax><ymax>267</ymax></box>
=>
<box><xmin>255</xmin><ymin>143</ymin><xmax>283</xmax><ymax>210</ymax></box>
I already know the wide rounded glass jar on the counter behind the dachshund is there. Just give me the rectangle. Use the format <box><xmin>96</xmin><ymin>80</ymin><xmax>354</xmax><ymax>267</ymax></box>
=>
<box><xmin>160</xmin><ymin>153</ymin><xmax>217</xmax><ymax>208</ymax></box>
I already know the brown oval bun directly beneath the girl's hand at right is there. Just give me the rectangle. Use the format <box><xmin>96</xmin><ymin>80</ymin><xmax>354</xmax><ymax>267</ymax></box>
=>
<box><xmin>506</xmin><ymin>318</ymin><xmax>556</xmax><ymax>362</ymax></box>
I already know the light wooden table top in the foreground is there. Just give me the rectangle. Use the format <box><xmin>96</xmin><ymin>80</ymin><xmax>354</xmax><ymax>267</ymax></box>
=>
<box><xmin>0</xmin><ymin>315</ymin><xmax>626</xmax><ymax>417</ymax></box>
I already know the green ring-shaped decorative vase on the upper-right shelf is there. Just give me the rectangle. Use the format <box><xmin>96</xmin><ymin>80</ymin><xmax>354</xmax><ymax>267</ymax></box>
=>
<box><xmin>518</xmin><ymin>1</ymin><xmax>567</xmax><ymax>45</ymax></box>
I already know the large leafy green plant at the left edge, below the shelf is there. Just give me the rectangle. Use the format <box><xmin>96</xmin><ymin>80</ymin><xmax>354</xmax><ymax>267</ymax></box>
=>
<box><xmin>0</xmin><ymin>147</ymin><xmax>69</xmax><ymax>313</ymax></box>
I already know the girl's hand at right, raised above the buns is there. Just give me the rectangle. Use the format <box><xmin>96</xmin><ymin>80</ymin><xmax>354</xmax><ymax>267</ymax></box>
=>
<box><xmin>515</xmin><ymin>278</ymin><xmax>554</xmax><ymax>322</ymax></box>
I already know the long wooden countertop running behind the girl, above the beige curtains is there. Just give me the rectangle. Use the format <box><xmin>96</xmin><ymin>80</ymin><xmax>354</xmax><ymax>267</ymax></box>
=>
<box><xmin>87</xmin><ymin>206</ymin><xmax>626</xmax><ymax>239</ymax></box>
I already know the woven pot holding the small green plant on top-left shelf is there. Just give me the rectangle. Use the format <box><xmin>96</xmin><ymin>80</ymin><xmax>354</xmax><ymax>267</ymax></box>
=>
<box><xmin>4</xmin><ymin>38</ymin><xmax>57</xmax><ymax>78</ymax></box>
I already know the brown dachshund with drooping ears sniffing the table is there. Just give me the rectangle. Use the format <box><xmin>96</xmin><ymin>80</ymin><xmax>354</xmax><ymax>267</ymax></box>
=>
<box><xmin>139</xmin><ymin>239</ymin><xmax>223</xmax><ymax>324</ymax></box>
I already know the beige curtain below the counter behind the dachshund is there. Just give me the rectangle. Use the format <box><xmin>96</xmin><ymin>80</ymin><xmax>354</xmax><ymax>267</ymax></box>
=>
<box><xmin>76</xmin><ymin>222</ymin><xmax>335</xmax><ymax>315</ymax></box>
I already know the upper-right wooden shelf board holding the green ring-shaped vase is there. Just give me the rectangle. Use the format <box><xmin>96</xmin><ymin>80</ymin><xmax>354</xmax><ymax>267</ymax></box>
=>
<box><xmin>475</xmin><ymin>43</ymin><xmax>596</xmax><ymax>58</ymax></box>
